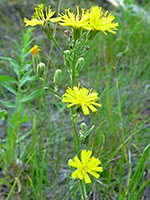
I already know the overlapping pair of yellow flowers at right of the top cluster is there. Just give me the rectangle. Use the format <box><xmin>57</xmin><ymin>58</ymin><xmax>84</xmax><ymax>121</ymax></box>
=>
<box><xmin>58</xmin><ymin>6</ymin><xmax>118</xmax><ymax>34</ymax></box>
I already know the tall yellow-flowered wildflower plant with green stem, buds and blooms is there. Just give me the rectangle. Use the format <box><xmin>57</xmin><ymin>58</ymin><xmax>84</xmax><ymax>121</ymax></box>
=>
<box><xmin>24</xmin><ymin>5</ymin><xmax>118</xmax><ymax>200</ymax></box>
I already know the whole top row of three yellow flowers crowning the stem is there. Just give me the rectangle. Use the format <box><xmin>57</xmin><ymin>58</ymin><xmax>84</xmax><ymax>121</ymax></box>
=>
<box><xmin>24</xmin><ymin>4</ymin><xmax>118</xmax><ymax>35</ymax></box>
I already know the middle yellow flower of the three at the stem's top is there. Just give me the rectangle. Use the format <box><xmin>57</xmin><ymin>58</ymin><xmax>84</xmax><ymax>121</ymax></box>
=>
<box><xmin>59</xmin><ymin>6</ymin><xmax>89</xmax><ymax>29</ymax></box>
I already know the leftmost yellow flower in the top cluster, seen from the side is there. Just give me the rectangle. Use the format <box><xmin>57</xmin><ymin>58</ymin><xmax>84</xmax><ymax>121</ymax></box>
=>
<box><xmin>24</xmin><ymin>4</ymin><xmax>59</xmax><ymax>27</ymax></box>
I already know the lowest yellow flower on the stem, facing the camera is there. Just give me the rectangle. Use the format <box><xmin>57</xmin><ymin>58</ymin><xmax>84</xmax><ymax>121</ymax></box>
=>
<box><xmin>68</xmin><ymin>150</ymin><xmax>103</xmax><ymax>183</ymax></box>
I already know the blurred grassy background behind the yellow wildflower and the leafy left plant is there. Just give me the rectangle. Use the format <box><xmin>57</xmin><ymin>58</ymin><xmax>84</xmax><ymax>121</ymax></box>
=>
<box><xmin>0</xmin><ymin>0</ymin><xmax>150</xmax><ymax>200</ymax></box>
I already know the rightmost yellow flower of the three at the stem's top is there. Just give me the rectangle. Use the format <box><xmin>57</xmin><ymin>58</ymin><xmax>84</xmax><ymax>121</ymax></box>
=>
<box><xmin>84</xmin><ymin>6</ymin><xmax>118</xmax><ymax>35</ymax></box>
